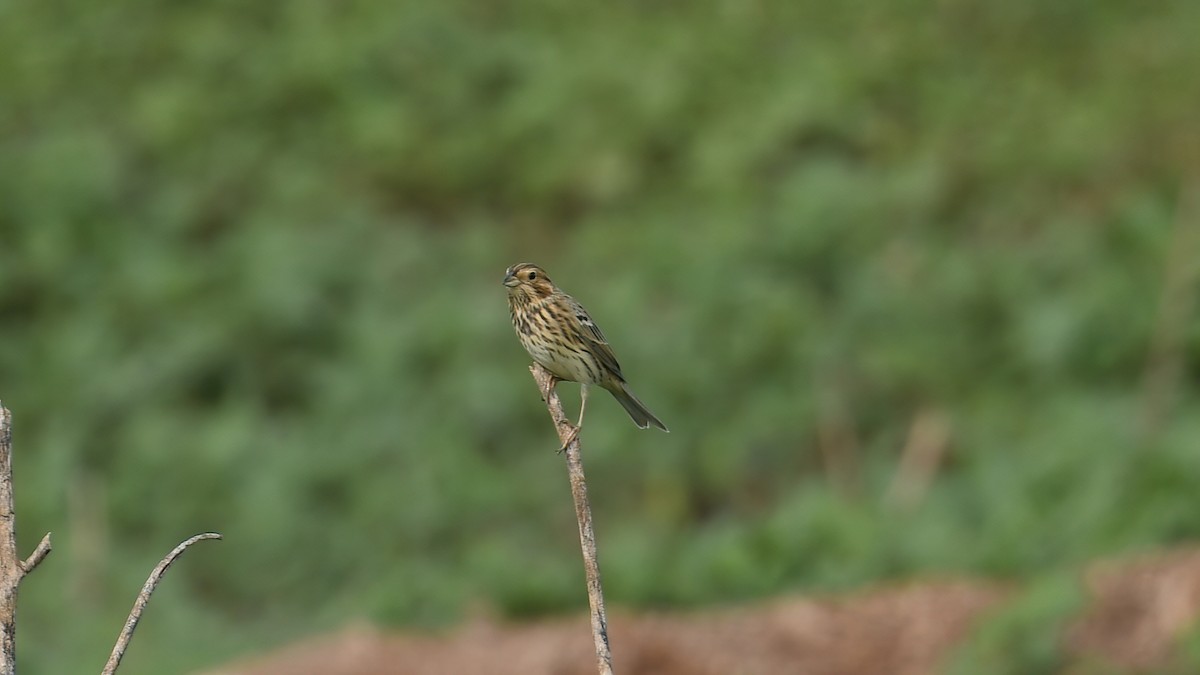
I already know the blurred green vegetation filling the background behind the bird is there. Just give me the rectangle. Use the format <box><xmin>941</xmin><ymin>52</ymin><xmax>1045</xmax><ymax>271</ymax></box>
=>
<box><xmin>0</xmin><ymin>0</ymin><xmax>1200</xmax><ymax>675</ymax></box>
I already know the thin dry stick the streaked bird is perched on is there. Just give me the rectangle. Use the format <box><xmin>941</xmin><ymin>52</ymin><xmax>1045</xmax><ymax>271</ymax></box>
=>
<box><xmin>529</xmin><ymin>364</ymin><xmax>612</xmax><ymax>675</ymax></box>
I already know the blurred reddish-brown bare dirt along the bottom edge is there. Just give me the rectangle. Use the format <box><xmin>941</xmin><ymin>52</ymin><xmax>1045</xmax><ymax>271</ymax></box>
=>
<box><xmin>201</xmin><ymin>549</ymin><xmax>1200</xmax><ymax>675</ymax></box>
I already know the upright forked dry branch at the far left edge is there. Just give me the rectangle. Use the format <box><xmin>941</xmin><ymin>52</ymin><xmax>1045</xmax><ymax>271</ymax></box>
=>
<box><xmin>0</xmin><ymin>402</ymin><xmax>50</xmax><ymax>675</ymax></box>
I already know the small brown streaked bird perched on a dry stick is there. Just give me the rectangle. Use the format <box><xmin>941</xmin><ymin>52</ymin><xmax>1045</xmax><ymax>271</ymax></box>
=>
<box><xmin>504</xmin><ymin>263</ymin><xmax>668</xmax><ymax>448</ymax></box>
